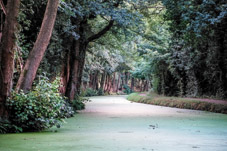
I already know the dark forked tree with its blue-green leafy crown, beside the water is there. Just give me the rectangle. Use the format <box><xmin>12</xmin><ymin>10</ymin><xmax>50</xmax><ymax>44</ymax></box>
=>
<box><xmin>62</xmin><ymin>0</ymin><xmax>144</xmax><ymax>100</ymax></box>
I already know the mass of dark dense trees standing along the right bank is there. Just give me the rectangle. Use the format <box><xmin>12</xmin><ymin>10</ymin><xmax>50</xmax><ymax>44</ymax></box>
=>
<box><xmin>140</xmin><ymin>0</ymin><xmax>227</xmax><ymax>98</ymax></box>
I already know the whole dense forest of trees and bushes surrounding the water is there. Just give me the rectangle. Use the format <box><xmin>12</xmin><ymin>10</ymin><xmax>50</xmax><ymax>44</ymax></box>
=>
<box><xmin>0</xmin><ymin>0</ymin><xmax>227</xmax><ymax>132</ymax></box>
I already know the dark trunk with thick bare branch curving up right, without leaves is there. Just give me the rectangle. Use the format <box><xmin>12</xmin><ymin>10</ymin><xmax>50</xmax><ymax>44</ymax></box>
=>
<box><xmin>65</xmin><ymin>20</ymin><xmax>114</xmax><ymax>100</ymax></box>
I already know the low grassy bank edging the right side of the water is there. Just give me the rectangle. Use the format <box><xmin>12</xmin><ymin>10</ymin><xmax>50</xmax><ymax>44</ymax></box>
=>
<box><xmin>127</xmin><ymin>93</ymin><xmax>227</xmax><ymax>114</ymax></box>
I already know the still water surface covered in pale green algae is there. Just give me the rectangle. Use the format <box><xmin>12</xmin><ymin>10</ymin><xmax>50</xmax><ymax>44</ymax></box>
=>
<box><xmin>0</xmin><ymin>96</ymin><xmax>227</xmax><ymax>151</ymax></box>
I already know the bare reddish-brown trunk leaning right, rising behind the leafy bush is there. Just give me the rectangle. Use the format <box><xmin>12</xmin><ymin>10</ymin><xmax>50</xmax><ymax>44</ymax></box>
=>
<box><xmin>16</xmin><ymin>0</ymin><xmax>59</xmax><ymax>92</ymax></box>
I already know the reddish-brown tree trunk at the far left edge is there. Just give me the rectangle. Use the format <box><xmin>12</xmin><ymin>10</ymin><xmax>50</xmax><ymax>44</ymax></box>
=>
<box><xmin>0</xmin><ymin>0</ymin><xmax>20</xmax><ymax>118</ymax></box>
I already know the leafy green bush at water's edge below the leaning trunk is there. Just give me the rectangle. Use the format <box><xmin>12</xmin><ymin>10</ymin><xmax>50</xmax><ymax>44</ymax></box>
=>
<box><xmin>7</xmin><ymin>77</ymin><xmax>74</xmax><ymax>131</ymax></box>
